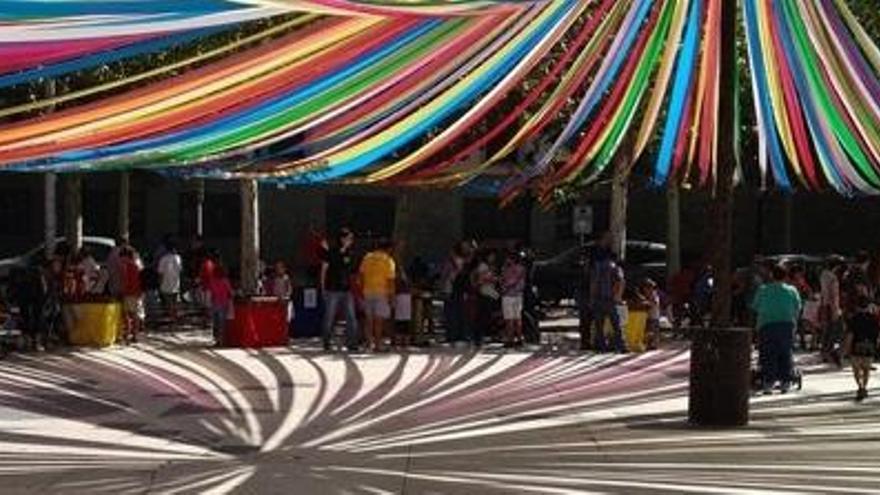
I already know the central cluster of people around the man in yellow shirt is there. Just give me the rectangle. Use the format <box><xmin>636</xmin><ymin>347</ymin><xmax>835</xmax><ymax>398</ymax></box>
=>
<box><xmin>319</xmin><ymin>228</ymin><xmax>527</xmax><ymax>350</ymax></box>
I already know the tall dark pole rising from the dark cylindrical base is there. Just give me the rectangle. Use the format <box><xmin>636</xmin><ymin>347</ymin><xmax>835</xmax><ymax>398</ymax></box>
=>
<box><xmin>709</xmin><ymin>0</ymin><xmax>737</xmax><ymax>327</ymax></box>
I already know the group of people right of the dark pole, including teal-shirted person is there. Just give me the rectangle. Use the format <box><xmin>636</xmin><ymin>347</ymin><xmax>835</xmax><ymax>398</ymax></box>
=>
<box><xmin>751</xmin><ymin>253</ymin><xmax>880</xmax><ymax>401</ymax></box>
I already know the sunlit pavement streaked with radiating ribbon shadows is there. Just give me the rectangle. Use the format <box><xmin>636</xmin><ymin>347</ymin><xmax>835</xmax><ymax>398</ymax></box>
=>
<box><xmin>0</xmin><ymin>334</ymin><xmax>880</xmax><ymax>494</ymax></box>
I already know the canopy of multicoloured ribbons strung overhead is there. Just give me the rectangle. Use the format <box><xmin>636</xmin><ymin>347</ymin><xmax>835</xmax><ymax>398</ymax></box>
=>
<box><xmin>0</xmin><ymin>0</ymin><xmax>880</xmax><ymax>197</ymax></box>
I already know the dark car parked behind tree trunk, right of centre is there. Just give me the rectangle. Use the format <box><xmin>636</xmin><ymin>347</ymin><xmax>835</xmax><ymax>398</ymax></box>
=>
<box><xmin>532</xmin><ymin>240</ymin><xmax>666</xmax><ymax>305</ymax></box>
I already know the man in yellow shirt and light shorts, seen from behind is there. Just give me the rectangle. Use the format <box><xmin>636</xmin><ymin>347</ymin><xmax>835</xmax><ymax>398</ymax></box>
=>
<box><xmin>360</xmin><ymin>241</ymin><xmax>397</xmax><ymax>350</ymax></box>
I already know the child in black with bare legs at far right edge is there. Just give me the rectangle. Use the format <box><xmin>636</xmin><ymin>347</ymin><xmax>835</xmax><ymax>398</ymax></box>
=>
<box><xmin>847</xmin><ymin>296</ymin><xmax>880</xmax><ymax>402</ymax></box>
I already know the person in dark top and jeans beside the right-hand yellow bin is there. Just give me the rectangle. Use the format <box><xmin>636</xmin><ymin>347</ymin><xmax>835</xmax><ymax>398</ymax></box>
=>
<box><xmin>581</xmin><ymin>251</ymin><xmax>627</xmax><ymax>353</ymax></box>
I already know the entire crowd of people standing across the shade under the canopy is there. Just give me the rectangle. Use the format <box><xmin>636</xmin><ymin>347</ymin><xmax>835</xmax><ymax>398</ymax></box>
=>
<box><xmin>6</xmin><ymin>228</ymin><xmax>880</xmax><ymax>400</ymax></box>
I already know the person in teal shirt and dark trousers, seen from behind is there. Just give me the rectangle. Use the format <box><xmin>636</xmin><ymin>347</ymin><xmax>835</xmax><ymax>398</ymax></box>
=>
<box><xmin>752</xmin><ymin>265</ymin><xmax>802</xmax><ymax>394</ymax></box>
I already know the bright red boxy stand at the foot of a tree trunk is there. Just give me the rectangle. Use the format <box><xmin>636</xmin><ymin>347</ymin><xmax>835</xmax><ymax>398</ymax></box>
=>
<box><xmin>226</xmin><ymin>297</ymin><xmax>288</xmax><ymax>348</ymax></box>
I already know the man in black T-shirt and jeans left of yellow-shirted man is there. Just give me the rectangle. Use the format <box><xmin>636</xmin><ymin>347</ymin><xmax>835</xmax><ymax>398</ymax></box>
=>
<box><xmin>318</xmin><ymin>228</ymin><xmax>360</xmax><ymax>351</ymax></box>
